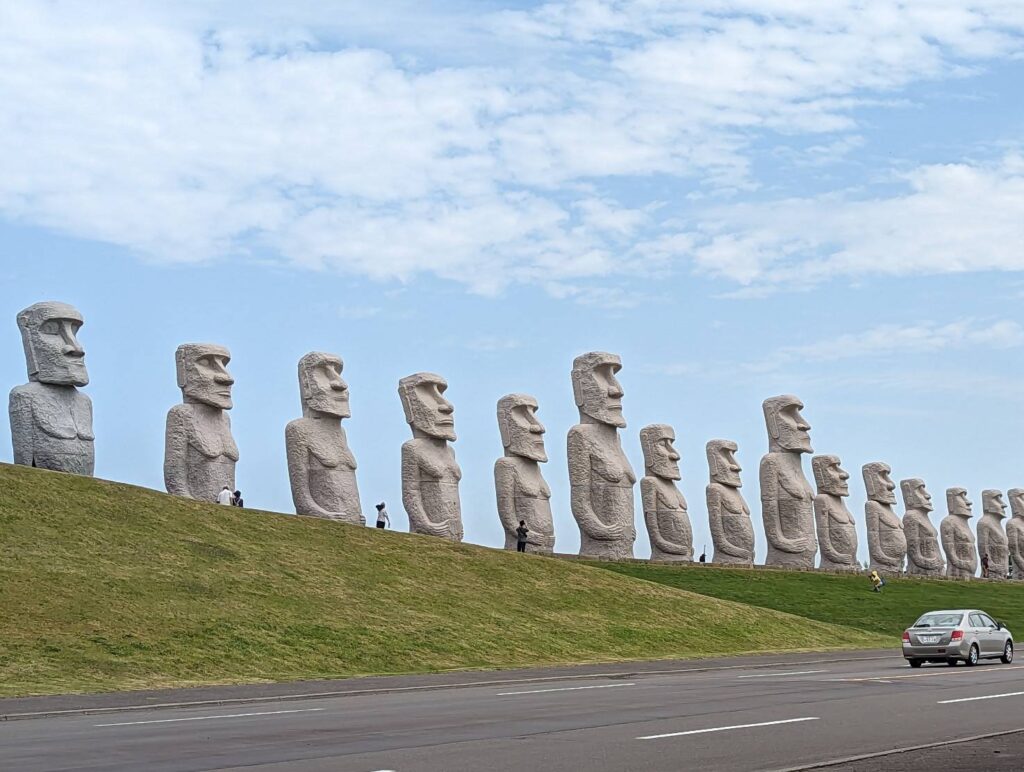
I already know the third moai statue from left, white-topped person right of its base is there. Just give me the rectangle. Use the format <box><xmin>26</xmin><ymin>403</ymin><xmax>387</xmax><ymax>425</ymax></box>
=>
<box><xmin>285</xmin><ymin>351</ymin><xmax>367</xmax><ymax>525</ymax></box>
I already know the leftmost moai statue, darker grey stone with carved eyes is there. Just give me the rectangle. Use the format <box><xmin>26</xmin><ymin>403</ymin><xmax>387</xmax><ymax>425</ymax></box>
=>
<box><xmin>9</xmin><ymin>301</ymin><xmax>95</xmax><ymax>477</ymax></box>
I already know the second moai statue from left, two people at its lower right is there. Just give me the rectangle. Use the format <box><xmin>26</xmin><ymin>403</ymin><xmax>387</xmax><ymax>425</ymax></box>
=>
<box><xmin>164</xmin><ymin>343</ymin><xmax>239</xmax><ymax>502</ymax></box>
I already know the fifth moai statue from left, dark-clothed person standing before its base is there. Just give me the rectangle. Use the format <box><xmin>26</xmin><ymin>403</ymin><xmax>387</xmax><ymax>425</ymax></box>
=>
<box><xmin>495</xmin><ymin>394</ymin><xmax>555</xmax><ymax>553</ymax></box>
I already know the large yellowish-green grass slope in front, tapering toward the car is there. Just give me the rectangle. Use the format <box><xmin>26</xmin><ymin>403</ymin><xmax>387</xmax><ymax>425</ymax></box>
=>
<box><xmin>0</xmin><ymin>465</ymin><xmax>880</xmax><ymax>695</ymax></box>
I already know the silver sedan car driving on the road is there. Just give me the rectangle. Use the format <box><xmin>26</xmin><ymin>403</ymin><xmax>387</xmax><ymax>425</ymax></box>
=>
<box><xmin>903</xmin><ymin>608</ymin><xmax>1014</xmax><ymax>668</ymax></box>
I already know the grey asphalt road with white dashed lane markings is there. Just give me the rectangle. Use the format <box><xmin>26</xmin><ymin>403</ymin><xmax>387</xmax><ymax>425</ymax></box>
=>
<box><xmin>6</xmin><ymin>652</ymin><xmax>1024</xmax><ymax>772</ymax></box>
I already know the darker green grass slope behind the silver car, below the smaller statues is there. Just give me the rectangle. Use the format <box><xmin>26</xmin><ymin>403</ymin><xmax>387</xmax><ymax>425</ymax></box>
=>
<box><xmin>593</xmin><ymin>563</ymin><xmax>1024</xmax><ymax>645</ymax></box>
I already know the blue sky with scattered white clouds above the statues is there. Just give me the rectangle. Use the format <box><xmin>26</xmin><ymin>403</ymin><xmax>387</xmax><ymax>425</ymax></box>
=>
<box><xmin>0</xmin><ymin>0</ymin><xmax>1024</xmax><ymax>559</ymax></box>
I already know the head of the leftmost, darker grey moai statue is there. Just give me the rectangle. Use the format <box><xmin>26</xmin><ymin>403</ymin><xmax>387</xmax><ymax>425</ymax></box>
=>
<box><xmin>17</xmin><ymin>302</ymin><xmax>89</xmax><ymax>386</ymax></box>
